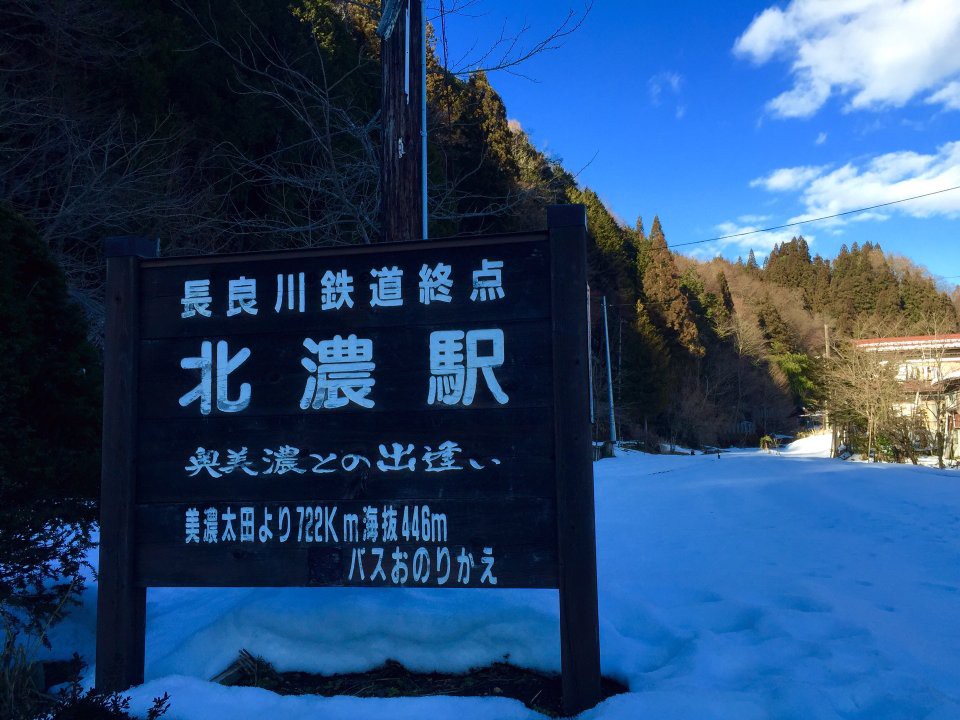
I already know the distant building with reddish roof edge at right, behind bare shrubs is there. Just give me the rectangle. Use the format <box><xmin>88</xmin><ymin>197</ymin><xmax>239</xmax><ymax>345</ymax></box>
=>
<box><xmin>855</xmin><ymin>333</ymin><xmax>960</xmax><ymax>457</ymax></box>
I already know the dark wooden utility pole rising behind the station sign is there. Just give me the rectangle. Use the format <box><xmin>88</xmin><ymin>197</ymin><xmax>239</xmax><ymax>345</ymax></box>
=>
<box><xmin>377</xmin><ymin>0</ymin><xmax>427</xmax><ymax>241</ymax></box>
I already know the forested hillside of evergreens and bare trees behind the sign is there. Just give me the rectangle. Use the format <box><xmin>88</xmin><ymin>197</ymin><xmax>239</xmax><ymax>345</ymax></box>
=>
<box><xmin>0</xmin><ymin>0</ymin><xmax>957</xmax><ymax>456</ymax></box>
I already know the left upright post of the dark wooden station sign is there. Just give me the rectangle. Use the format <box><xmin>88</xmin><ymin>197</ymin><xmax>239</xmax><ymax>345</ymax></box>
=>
<box><xmin>96</xmin><ymin>238</ymin><xmax>155</xmax><ymax>691</ymax></box>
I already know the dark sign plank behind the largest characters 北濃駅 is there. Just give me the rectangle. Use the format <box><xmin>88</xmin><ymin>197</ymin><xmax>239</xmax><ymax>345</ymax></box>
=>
<box><xmin>139</xmin><ymin>321</ymin><xmax>551</xmax><ymax>422</ymax></box>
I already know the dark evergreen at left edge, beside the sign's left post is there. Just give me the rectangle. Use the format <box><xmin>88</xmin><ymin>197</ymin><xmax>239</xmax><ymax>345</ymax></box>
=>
<box><xmin>0</xmin><ymin>206</ymin><xmax>101</xmax><ymax>631</ymax></box>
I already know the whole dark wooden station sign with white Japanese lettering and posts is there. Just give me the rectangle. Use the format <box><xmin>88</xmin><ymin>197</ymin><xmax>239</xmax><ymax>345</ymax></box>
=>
<box><xmin>96</xmin><ymin>205</ymin><xmax>600</xmax><ymax>713</ymax></box>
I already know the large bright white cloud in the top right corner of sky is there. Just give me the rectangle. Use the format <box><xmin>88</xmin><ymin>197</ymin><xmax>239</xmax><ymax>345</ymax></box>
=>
<box><xmin>733</xmin><ymin>0</ymin><xmax>960</xmax><ymax>117</ymax></box>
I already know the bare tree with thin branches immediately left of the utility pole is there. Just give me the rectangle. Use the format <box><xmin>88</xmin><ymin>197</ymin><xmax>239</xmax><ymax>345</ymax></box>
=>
<box><xmin>174</xmin><ymin>2</ymin><xmax>380</xmax><ymax>247</ymax></box>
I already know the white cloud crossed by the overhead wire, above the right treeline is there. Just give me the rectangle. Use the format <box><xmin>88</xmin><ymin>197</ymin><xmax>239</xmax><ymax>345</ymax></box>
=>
<box><xmin>750</xmin><ymin>142</ymin><xmax>960</xmax><ymax>227</ymax></box>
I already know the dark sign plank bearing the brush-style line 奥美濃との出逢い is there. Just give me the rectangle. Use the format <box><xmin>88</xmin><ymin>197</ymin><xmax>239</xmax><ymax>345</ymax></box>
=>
<box><xmin>139</xmin><ymin>408</ymin><xmax>556</xmax><ymax>502</ymax></box>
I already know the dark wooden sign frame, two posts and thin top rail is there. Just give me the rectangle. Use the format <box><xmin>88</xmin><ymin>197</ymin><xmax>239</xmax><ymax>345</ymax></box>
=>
<box><xmin>96</xmin><ymin>205</ymin><xmax>600</xmax><ymax>714</ymax></box>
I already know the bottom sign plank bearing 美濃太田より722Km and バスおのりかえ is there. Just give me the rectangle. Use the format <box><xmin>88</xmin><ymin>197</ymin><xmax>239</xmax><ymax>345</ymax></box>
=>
<box><xmin>137</xmin><ymin>498</ymin><xmax>557</xmax><ymax>587</ymax></box>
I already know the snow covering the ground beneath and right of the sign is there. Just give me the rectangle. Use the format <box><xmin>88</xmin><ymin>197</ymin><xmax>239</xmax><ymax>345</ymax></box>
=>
<box><xmin>43</xmin><ymin>437</ymin><xmax>960</xmax><ymax>720</ymax></box>
